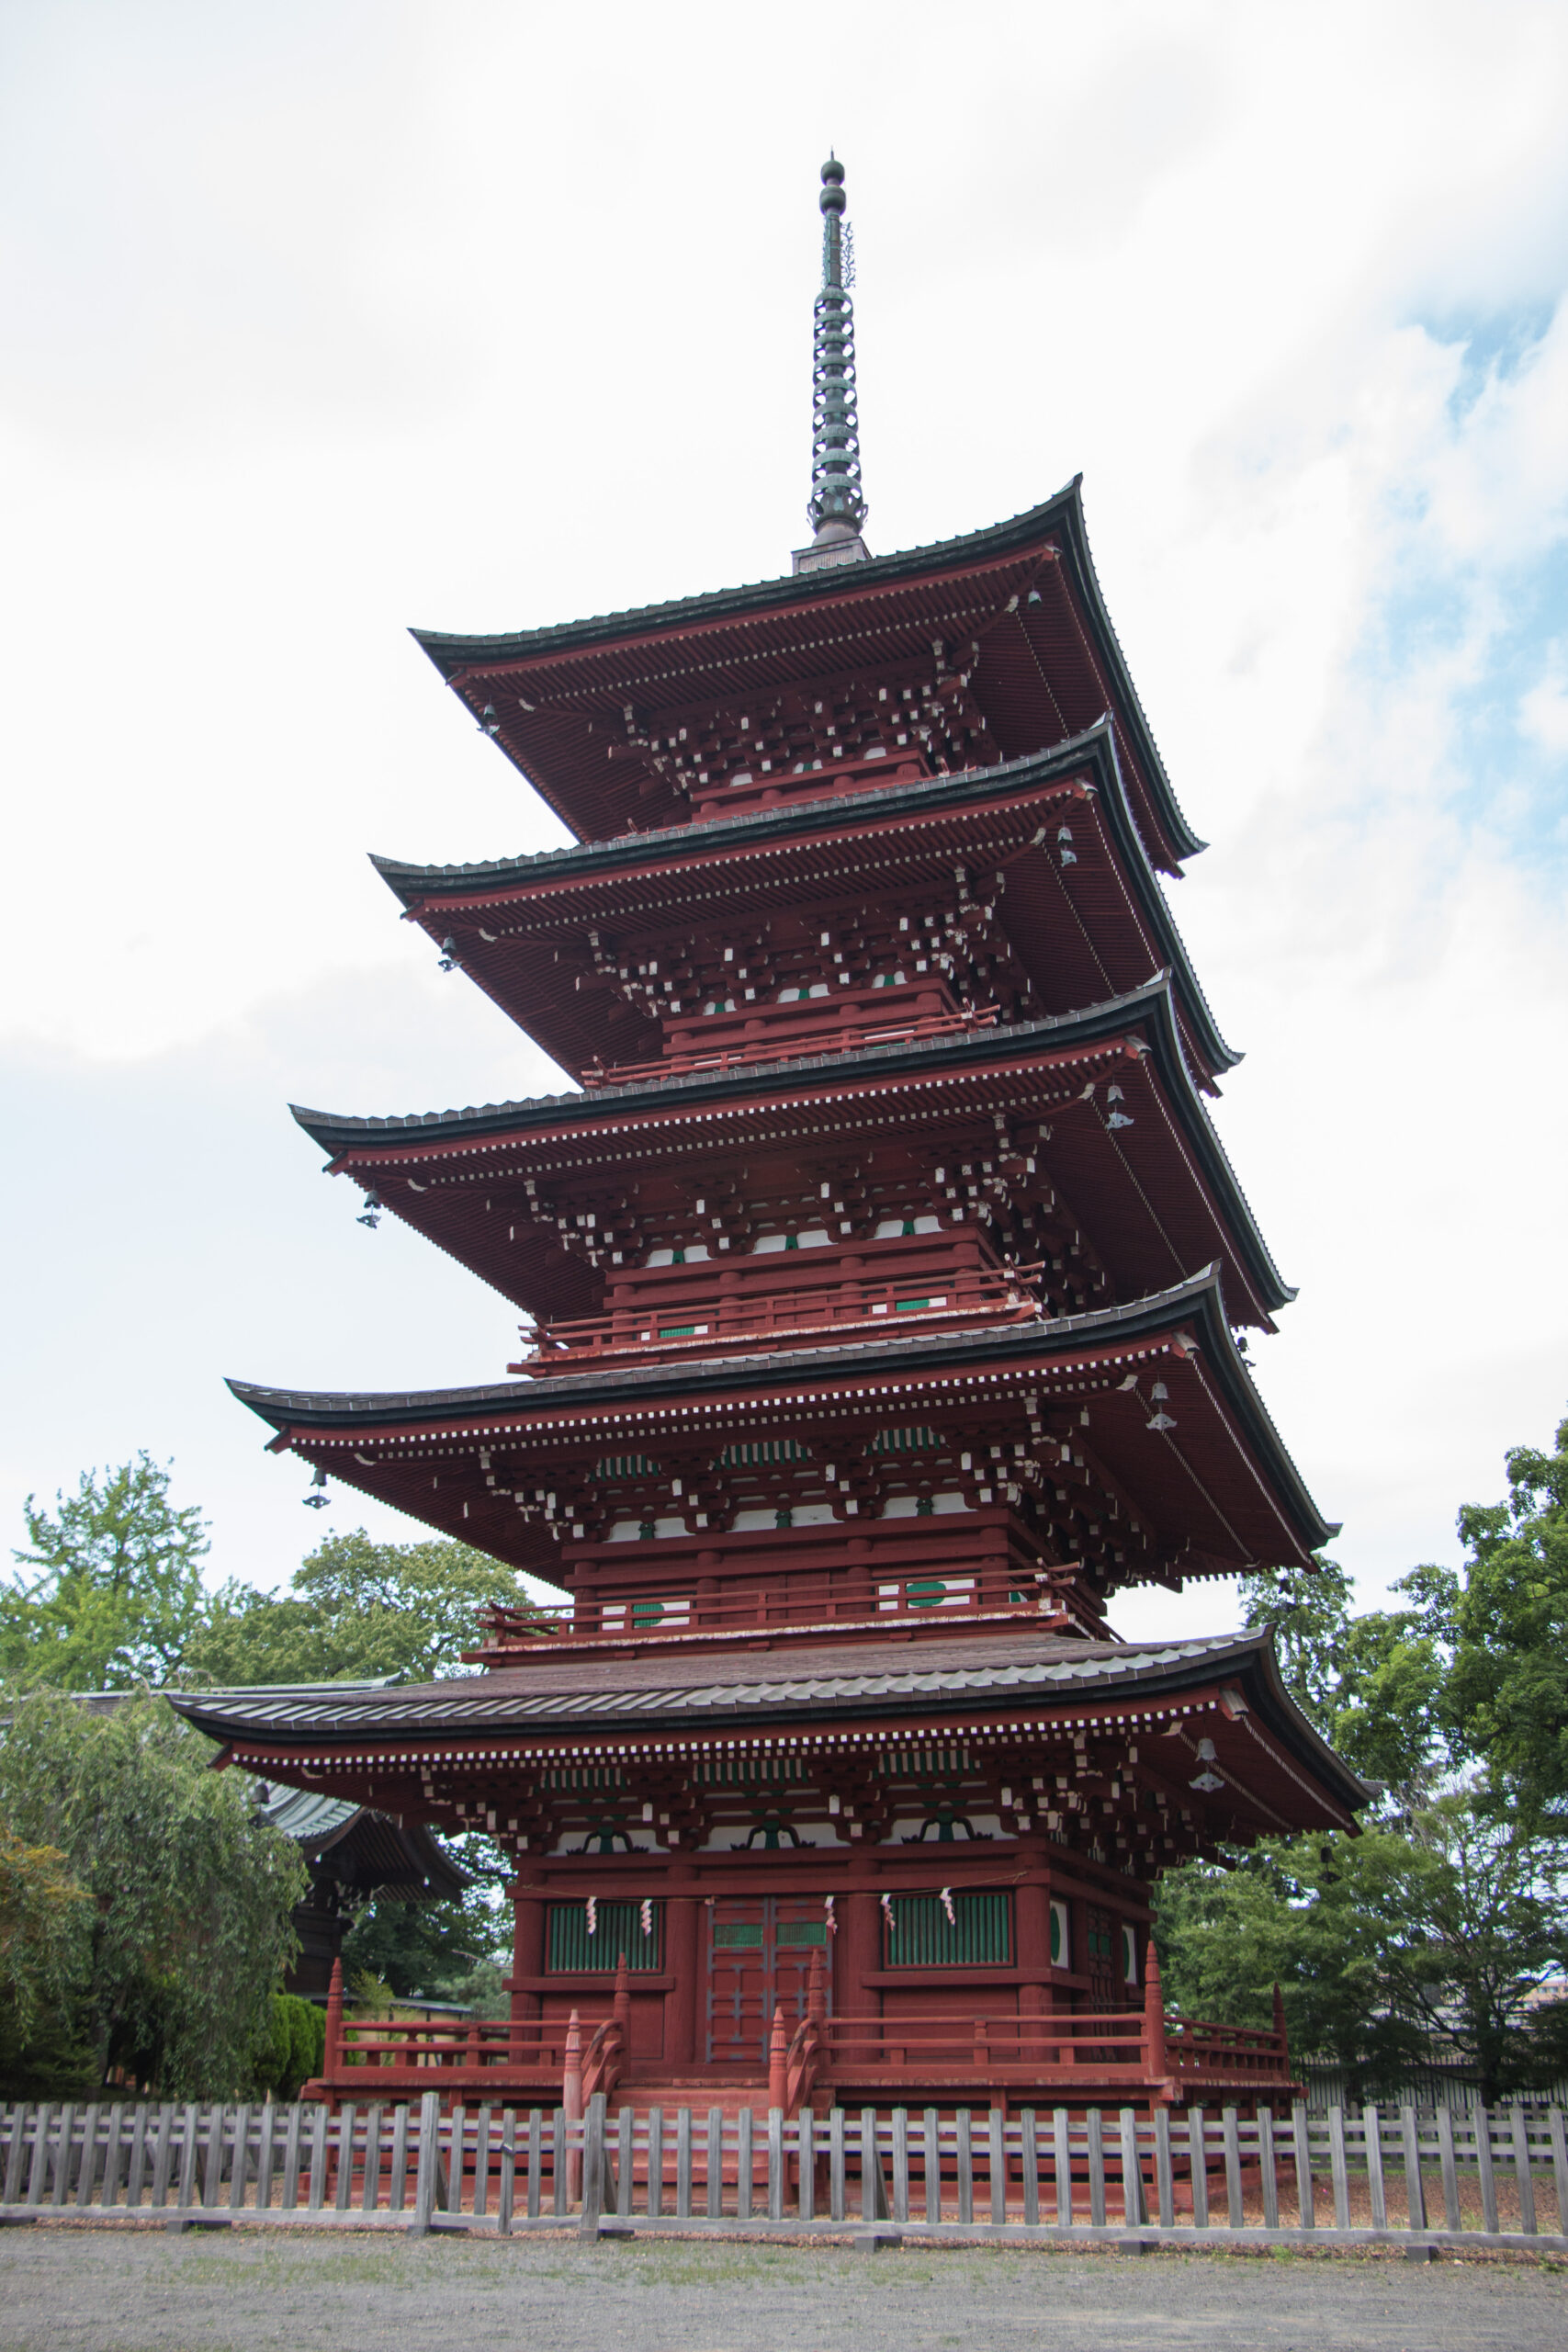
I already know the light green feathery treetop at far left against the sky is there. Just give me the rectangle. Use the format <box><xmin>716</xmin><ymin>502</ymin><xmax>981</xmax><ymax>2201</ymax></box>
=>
<box><xmin>0</xmin><ymin>1453</ymin><xmax>209</xmax><ymax>1691</ymax></box>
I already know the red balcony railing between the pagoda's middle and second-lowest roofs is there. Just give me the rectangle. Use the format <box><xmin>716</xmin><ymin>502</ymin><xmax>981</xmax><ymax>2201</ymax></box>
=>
<box><xmin>505</xmin><ymin>1265</ymin><xmax>1043</xmax><ymax>1374</ymax></box>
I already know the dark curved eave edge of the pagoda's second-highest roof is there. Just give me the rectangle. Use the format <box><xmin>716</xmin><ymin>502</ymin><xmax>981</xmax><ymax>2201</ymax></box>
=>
<box><xmin>371</xmin><ymin>719</ymin><xmax>1241</xmax><ymax>1072</ymax></box>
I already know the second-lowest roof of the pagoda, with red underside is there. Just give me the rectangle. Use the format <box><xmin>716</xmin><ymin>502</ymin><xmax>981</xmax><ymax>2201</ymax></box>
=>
<box><xmin>231</xmin><ymin>1268</ymin><xmax>1333</xmax><ymax>1580</ymax></box>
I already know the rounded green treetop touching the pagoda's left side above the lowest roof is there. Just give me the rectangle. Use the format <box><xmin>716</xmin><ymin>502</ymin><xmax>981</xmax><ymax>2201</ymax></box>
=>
<box><xmin>188</xmin><ymin>1526</ymin><xmax>545</xmax><ymax>1687</ymax></box>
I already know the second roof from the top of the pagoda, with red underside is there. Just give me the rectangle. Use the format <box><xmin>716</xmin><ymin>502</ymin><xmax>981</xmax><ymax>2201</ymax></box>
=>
<box><xmin>371</xmin><ymin>719</ymin><xmax>1241</xmax><ymax>1080</ymax></box>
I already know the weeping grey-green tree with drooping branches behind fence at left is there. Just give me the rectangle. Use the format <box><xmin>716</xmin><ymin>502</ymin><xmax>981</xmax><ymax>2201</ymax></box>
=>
<box><xmin>0</xmin><ymin>1691</ymin><xmax>306</xmax><ymax>2098</ymax></box>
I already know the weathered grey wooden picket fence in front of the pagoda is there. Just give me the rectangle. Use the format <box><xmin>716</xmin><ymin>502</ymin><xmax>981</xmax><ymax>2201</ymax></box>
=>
<box><xmin>0</xmin><ymin>2093</ymin><xmax>1568</xmax><ymax>2251</ymax></box>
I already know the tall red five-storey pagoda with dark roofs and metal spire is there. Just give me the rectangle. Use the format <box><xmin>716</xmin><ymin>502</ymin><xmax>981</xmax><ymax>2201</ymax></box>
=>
<box><xmin>184</xmin><ymin>163</ymin><xmax>1366</xmax><ymax>2108</ymax></box>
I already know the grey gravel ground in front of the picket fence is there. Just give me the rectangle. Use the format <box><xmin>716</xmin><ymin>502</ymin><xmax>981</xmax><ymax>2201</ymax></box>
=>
<box><xmin>0</xmin><ymin>2227</ymin><xmax>1568</xmax><ymax>2352</ymax></box>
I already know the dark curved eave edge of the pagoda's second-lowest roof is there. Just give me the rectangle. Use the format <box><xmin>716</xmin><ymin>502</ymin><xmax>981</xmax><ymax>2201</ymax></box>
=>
<box><xmin>228</xmin><ymin>1265</ymin><xmax>1336</xmax><ymax>1553</ymax></box>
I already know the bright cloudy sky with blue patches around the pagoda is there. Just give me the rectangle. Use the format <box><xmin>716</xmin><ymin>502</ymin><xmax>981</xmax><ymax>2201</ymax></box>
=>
<box><xmin>0</xmin><ymin>0</ymin><xmax>1568</xmax><ymax>1634</ymax></box>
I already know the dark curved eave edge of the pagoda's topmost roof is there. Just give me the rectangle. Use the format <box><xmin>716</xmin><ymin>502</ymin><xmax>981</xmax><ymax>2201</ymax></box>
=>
<box><xmin>409</xmin><ymin>475</ymin><xmax>1206</xmax><ymax>858</ymax></box>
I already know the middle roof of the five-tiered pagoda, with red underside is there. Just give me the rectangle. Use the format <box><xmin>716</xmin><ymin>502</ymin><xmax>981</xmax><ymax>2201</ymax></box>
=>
<box><xmin>294</xmin><ymin>974</ymin><xmax>1295</xmax><ymax>1329</ymax></box>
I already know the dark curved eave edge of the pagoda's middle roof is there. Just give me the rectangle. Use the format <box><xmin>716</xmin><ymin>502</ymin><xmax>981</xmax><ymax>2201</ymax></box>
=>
<box><xmin>291</xmin><ymin>971</ymin><xmax>1295</xmax><ymax>1315</ymax></box>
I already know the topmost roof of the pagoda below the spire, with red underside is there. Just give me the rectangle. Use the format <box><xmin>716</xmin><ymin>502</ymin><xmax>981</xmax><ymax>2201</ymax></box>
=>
<box><xmin>413</xmin><ymin>480</ymin><xmax>1203</xmax><ymax>873</ymax></box>
